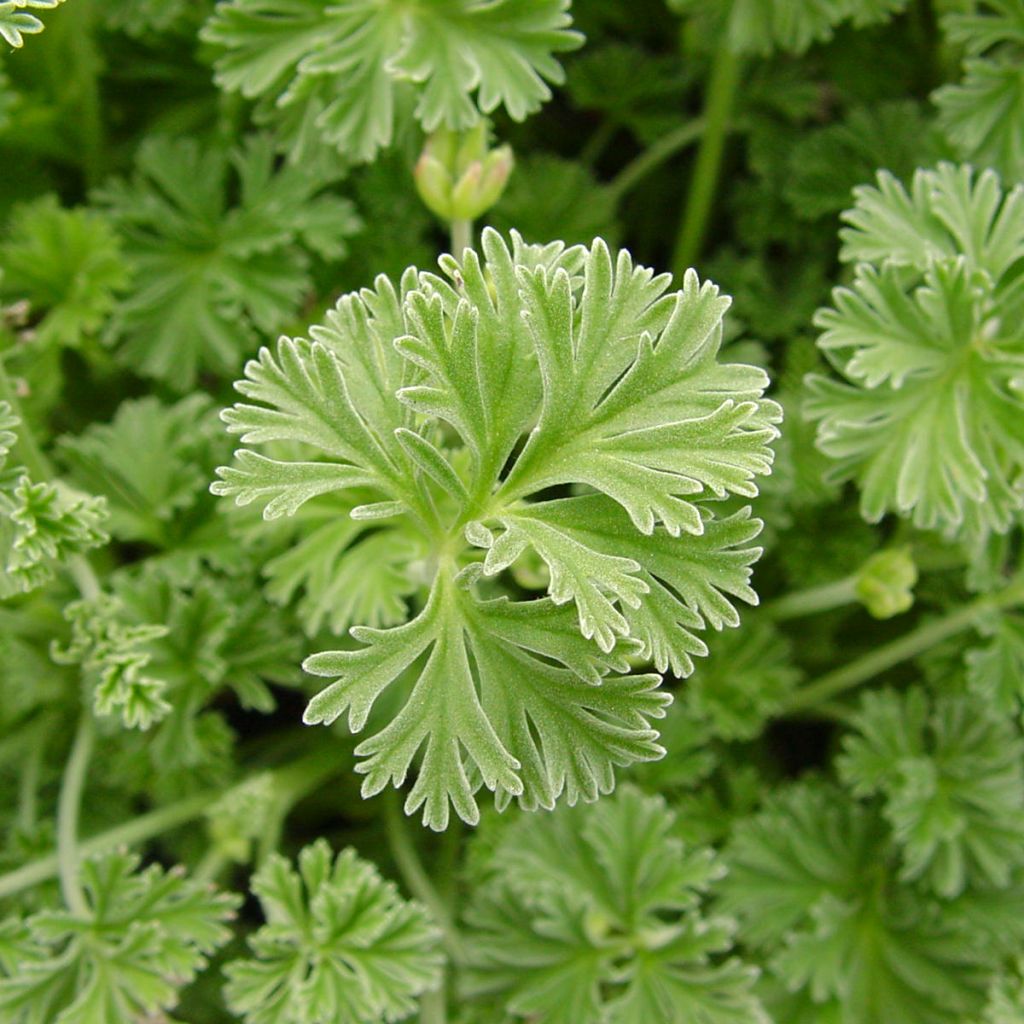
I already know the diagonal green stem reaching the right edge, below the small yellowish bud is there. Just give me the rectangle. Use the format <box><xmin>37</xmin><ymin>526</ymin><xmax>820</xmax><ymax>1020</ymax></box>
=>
<box><xmin>782</xmin><ymin>580</ymin><xmax>1024</xmax><ymax>715</ymax></box>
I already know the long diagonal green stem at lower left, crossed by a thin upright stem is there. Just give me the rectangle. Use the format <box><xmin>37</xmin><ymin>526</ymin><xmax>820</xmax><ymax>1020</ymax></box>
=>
<box><xmin>0</xmin><ymin>750</ymin><xmax>341</xmax><ymax>899</ymax></box>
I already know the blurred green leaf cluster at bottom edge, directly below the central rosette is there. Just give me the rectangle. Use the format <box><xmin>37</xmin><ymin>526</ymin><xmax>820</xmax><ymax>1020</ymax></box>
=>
<box><xmin>466</xmin><ymin>788</ymin><xmax>767</xmax><ymax>1024</ymax></box>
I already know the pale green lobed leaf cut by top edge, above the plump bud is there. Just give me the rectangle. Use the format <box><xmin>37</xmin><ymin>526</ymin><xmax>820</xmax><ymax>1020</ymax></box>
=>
<box><xmin>203</xmin><ymin>0</ymin><xmax>583</xmax><ymax>162</ymax></box>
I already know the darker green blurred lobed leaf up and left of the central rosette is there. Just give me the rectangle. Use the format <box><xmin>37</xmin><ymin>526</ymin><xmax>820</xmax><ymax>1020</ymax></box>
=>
<box><xmin>97</xmin><ymin>136</ymin><xmax>358</xmax><ymax>391</ymax></box>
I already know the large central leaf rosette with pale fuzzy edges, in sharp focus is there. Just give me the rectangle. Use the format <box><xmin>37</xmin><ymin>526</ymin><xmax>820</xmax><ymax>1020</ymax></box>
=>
<box><xmin>214</xmin><ymin>230</ymin><xmax>781</xmax><ymax>829</ymax></box>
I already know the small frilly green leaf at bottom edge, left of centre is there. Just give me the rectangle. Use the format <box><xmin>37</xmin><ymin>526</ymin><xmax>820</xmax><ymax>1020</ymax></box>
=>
<box><xmin>225</xmin><ymin>840</ymin><xmax>441</xmax><ymax>1024</ymax></box>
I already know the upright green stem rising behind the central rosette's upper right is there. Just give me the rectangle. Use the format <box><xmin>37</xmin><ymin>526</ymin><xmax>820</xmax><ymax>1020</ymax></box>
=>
<box><xmin>672</xmin><ymin>43</ymin><xmax>741</xmax><ymax>278</ymax></box>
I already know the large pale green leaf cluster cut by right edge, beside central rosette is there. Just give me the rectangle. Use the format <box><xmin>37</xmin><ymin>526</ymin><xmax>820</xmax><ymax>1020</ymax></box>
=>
<box><xmin>807</xmin><ymin>164</ymin><xmax>1024</xmax><ymax>539</ymax></box>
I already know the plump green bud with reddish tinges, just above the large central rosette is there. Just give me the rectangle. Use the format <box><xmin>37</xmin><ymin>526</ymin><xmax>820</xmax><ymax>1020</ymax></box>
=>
<box><xmin>414</xmin><ymin>121</ymin><xmax>514</xmax><ymax>221</ymax></box>
